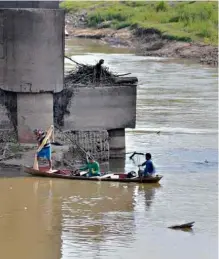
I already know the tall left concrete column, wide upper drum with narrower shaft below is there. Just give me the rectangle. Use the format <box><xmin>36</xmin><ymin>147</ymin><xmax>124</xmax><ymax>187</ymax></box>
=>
<box><xmin>0</xmin><ymin>8</ymin><xmax>64</xmax><ymax>143</ymax></box>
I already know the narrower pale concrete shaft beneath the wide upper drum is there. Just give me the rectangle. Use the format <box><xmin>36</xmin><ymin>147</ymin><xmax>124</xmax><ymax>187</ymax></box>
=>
<box><xmin>17</xmin><ymin>93</ymin><xmax>53</xmax><ymax>143</ymax></box>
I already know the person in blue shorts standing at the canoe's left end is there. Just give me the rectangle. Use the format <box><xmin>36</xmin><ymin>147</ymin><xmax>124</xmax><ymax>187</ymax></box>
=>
<box><xmin>33</xmin><ymin>129</ymin><xmax>52</xmax><ymax>170</ymax></box>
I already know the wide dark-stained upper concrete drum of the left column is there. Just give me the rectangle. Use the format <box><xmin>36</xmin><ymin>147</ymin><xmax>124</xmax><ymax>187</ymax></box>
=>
<box><xmin>0</xmin><ymin>9</ymin><xmax>64</xmax><ymax>92</ymax></box>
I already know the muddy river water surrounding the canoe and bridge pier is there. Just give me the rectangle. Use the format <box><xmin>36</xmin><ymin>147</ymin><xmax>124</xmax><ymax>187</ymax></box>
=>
<box><xmin>0</xmin><ymin>39</ymin><xmax>218</xmax><ymax>259</ymax></box>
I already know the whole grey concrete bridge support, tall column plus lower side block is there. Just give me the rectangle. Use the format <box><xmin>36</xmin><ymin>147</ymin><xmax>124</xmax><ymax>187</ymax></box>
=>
<box><xmin>0</xmin><ymin>1</ymin><xmax>136</xmax><ymax>157</ymax></box>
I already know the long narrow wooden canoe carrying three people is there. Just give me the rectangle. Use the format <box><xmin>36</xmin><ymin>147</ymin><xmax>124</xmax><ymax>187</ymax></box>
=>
<box><xmin>23</xmin><ymin>166</ymin><xmax>163</xmax><ymax>184</ymax></box>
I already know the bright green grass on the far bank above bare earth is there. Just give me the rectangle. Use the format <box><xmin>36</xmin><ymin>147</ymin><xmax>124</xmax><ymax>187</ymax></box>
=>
<box><xmin>60</xmin><ymin>1</ymin><xmax>218</xmax><ymax>45</ymax></box>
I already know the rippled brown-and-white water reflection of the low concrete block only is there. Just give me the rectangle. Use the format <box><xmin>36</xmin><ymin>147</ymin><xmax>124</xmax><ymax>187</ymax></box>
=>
<box><xmin>62</xmin><ymin>183</ymin><xmax>135</xmax><ymax>256</ymax></box>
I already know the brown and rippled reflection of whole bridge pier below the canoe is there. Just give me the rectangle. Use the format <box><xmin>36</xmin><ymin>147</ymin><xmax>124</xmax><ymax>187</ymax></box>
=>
<box><xmin>0</xmin><ymin>177</ymin><xmax>159</xmax><ymax>259</ymax></box>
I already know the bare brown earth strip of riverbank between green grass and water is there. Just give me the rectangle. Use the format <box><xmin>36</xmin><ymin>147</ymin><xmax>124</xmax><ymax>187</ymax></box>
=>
<box><xmin>66</xmin><ymin>24</ymin><xmax>218</xmax><ymax>66</ymax></box>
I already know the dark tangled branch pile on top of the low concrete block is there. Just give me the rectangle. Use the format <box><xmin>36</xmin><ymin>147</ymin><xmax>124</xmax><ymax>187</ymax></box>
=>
<box><xmin>65</xmin><ymin>57</ymin><xmax>129</xmax><ymax>88</ymax></box>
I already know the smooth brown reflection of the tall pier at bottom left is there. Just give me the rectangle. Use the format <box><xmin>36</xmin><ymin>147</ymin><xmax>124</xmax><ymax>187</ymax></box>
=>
<box><xmin>0</xmin><ymin>178</ymin><xmax>61</xmax><ymax>259</ymax></box>
